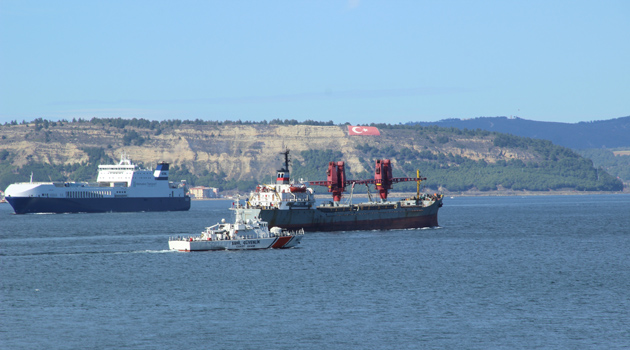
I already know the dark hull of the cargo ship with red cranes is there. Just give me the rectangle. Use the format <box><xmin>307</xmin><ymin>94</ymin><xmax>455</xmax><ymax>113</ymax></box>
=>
<box><xmin>246</xmin><ymin>202</ymin><xmax>440</xmax><ymax>232</ymax></box>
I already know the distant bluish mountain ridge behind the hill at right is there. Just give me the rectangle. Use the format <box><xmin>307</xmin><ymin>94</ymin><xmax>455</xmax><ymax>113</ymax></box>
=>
<box><xmin>408</xmin><ymin>116</ymin><xmax>630</xmax><ymax>149</ymax></box>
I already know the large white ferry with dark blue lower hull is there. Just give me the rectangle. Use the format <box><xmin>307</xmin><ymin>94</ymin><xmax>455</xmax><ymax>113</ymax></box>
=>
<box><xmin>5</xmin><ymin>153</ymin><xmax>190</xmax><ymax>214</ymax></box>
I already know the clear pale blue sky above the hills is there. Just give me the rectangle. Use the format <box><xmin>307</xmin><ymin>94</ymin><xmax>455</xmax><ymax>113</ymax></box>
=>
<box><xmin>0</xmin><ymin>0</ymin><xmax>630</xmax><ymax>125</ymax></box>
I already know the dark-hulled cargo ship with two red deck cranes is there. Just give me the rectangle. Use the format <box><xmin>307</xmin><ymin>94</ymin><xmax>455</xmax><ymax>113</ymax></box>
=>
<box><xmin>244</xmin><ymin>150</ymin><xmax>443</xmax><ymax>232</ymax></box>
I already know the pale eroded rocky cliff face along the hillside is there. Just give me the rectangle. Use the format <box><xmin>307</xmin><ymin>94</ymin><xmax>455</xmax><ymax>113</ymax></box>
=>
<box><xmin>0</xmin><ymin>122</ymin><xmax>537</xmax><ymax>180</ymax></box>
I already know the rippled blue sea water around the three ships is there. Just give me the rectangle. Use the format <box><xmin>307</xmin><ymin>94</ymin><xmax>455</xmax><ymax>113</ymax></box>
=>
<box><xmin>0</xmin><ymin>194</ymin><xmax>630</xmax><ymax>350</ymax></box>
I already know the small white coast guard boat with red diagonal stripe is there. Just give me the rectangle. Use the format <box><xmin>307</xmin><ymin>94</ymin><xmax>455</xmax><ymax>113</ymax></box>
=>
<box><xmin>168</xmin><ymin>203</ymin><xmax>304</xmax><ymax>252</ymax></box>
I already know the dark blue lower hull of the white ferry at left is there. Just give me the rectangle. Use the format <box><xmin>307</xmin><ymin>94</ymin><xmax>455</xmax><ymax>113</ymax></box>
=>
<box><xmin>6</xmin><ymin>197</ymin><xmax>190</xmax><ymax>214</ymax></box>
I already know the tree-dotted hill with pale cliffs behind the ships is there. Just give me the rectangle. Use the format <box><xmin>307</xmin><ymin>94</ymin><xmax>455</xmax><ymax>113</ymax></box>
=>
<box><xmin>0</xmin><ymin>119</ymin><xmax>622</xmax><ymax>192</ymax></box>
